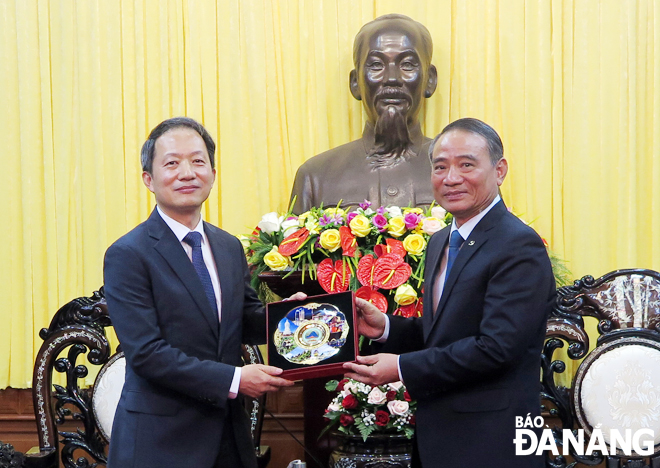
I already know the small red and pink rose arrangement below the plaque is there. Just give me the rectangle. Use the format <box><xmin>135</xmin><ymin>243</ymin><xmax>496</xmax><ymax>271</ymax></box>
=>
<box><xmin>323</xmin><ymin>379</ymin><xmax>417</xmax><ymax>440</ymax></box>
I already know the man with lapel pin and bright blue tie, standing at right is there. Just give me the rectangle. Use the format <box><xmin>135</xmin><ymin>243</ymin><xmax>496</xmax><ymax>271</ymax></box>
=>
<box><xmin>345</xmin><ymin>119</ymin><xmax>555</xmax><ymax>468</ymax></box>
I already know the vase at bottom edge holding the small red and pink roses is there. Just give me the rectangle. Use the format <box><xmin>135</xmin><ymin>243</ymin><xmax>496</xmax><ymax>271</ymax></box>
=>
<box><xmin>328</xmin><ymin>433</ymin><xmax>413</xmax><ymax>468</ymax></box>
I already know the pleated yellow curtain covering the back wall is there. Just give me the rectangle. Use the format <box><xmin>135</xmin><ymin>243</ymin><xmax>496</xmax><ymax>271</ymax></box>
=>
<box><xmin>0</xmin><ymin>0</ymin><xmax>660</xmax><ymax>388</ymax></box>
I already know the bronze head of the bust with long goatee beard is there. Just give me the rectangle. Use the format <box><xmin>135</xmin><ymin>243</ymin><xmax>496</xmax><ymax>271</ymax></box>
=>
<box><xmin>350</xmin><ymin>14</ymin><xmax>437</xmax><ymax>165</ymax></box>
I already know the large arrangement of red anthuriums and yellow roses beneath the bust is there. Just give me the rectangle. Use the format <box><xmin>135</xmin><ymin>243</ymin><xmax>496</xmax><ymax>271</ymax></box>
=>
<box><xmin>246</xmin><ymin>200</ymin><xmax>451</xmax><ymax>317</ymax></box>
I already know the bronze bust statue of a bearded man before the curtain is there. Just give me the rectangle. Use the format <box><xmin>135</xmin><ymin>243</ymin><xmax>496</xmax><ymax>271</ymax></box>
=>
<box><xmin>291</xmin><ymin>14</ymin><xmax>437</xmax><ymax>214</ymax></box>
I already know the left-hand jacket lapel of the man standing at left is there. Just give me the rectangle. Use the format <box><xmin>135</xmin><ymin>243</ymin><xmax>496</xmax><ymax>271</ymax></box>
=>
<box><xmin>148</xmin><ymin>209</ymin><xmax>218</xmax><ymax>339</ymax></box>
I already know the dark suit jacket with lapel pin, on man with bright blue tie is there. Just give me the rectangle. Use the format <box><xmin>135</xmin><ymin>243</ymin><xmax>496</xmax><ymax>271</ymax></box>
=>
<box><xmin>383</xmin><ymin>202</ymin><xmax>555</xmax><ymax>468</ymax></box>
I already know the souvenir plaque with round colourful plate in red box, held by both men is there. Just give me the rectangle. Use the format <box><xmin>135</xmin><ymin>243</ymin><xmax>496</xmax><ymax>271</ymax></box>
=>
<box><xmin>266</xmin><ymin>291</ymin><xmax>358</xmax><ymax>380</ymax></box>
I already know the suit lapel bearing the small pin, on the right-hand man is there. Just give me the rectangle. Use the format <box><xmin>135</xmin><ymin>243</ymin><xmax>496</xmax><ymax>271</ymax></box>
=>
<box><xmin>424</xmin><ymin>201</ymin><xmax>506</xmax><ymax>341</ymax></box>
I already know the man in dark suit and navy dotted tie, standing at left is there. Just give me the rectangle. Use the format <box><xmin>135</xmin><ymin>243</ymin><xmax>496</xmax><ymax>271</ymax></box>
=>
<box><xmin>104</xmin><ymin>117</ymin><xmax>292</xmax><ymax>468</ymax></box>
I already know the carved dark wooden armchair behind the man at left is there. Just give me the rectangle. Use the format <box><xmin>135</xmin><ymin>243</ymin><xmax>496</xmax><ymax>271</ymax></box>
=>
<box><xmin>0</xmin><ymin>287</ymin><xmax>270</xmax><ymax>468</ymax></box>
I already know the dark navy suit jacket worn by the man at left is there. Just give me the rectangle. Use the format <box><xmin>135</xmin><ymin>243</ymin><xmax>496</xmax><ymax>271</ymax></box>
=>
<box><xmin>104</xmin><ymin>210</ymin><xmax>265</xmax><ymax>468</ymax></box>
